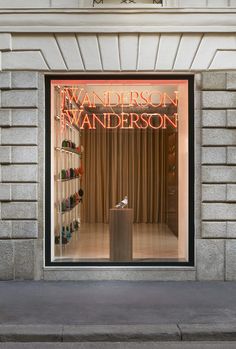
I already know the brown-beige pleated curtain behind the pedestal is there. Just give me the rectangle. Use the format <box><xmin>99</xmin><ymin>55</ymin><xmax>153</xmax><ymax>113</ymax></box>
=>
<box><xmin>82</xmin><ymin>128</ymin><xmax>166</xmax><ymax>223</ymax></box>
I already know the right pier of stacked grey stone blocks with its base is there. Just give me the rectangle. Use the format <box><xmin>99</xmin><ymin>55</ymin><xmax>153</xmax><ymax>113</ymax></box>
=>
<box><xmin>200</xmin><ymin>72</ymin><xmax>236</xmax><ymax>280</ymax></box>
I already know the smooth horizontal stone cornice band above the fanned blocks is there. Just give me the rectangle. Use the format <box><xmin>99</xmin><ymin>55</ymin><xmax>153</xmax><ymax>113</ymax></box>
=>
<box><xmin>0</xmin><ymin>8</ymin><xmax>236</xmax><ymax>33</ymax></box>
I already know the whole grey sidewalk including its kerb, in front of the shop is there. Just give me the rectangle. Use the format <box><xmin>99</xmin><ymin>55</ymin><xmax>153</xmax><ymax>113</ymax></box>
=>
<box><xmin>0</xmin><ymin>281</ymin><xmax>236</xmax><ymax>342</ymax></box>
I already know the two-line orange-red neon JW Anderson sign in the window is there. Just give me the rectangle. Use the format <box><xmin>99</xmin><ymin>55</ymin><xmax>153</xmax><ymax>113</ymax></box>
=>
<box><xmin>61</xmin><ymin>88</ymin><xmax>179</xmax><ymax>130</ymax></box>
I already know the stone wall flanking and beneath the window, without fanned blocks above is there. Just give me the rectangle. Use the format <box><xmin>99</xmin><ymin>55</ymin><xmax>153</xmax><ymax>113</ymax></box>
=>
<box><xmin>0</xmin><ymin>72</ymin><xmax>236</xmax><ymax>280</ymax></box>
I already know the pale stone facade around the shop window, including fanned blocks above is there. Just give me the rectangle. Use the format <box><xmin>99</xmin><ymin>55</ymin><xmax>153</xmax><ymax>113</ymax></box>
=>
<box><xmin>0</xmin><ymin>4</ymin><xmax>236</xmax><ymax>280</ymax></box>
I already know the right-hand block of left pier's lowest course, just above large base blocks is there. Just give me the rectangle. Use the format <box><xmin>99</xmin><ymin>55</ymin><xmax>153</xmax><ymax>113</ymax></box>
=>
<box><xmin>12</xmin><ymin>221</ymin><xmax>38</xmax><ymax>239</ymax></box>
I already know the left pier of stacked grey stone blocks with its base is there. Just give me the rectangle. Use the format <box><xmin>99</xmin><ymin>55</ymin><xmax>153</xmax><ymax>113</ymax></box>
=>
<box><xmin>0</xmin><ymin>71</ymin><xmax>38</xmax><ymax>280</ymax></box>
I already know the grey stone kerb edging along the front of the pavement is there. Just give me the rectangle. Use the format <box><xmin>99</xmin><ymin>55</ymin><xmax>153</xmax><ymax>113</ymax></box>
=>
<box><xmin>0</xmin><ymin>324</ymin><xmax>236</xmax><ymax>343</ymax></box>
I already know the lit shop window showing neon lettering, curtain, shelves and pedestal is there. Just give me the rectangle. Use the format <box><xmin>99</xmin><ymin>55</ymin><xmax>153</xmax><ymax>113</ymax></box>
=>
<box><xmin>46</xmin><ymin>77</ymin><xmax>193</xmax><ymax>265</ymax></box>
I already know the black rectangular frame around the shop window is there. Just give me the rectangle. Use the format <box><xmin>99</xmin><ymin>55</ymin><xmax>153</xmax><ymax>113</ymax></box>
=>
<box><xmin>44</xmin><ymin>74</ymin><xmax>195</xmax><ymax>267</ymax></box>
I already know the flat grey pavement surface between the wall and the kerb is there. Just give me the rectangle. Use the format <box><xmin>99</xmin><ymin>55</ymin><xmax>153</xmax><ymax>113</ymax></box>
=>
<box><xmin>0</xmin><ymin>281</ymin><xmax>236</xmax><ymax>325</ymax></box>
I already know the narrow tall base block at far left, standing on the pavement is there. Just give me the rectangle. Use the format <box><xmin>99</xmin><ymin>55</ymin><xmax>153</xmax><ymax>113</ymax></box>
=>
<box><xmin>0</xmin><ymin>240</ymin><xmax>14</xmax><ymax>280</ymax></box>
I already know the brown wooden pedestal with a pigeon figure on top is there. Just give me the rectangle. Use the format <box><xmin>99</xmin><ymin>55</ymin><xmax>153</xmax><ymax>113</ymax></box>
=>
<box><xmin>109</xmin><ymin>208</ymin><xmax>133</xmax><ymax>262</ymax></box>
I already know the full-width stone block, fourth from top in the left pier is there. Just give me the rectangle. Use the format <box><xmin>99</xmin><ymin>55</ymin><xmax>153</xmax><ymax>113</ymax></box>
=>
<box><xmin>2</xmin><ymin>127</ymin><xmax>38</xmax><ymax>145</ymax></box>
